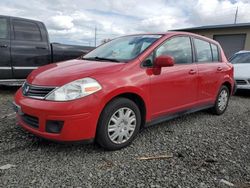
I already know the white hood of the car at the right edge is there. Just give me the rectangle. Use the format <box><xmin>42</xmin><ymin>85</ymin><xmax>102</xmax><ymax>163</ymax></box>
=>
<box><xmin>233</xmin><ymin>63</ymin><xmax>250</xmax><ymax>78</ymax></box>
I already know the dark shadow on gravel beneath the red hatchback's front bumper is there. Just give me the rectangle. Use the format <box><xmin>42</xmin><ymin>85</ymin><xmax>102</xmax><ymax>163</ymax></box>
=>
<box><xmin>0</xmin><ymin>125</ymin><xmax>105</xmax><ymax>155</ymax></box>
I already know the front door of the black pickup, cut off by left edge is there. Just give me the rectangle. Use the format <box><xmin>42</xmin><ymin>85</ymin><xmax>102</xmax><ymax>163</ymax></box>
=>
<box><xmin>0</xmin><ymin>17</ymin><xmax>12</xmax><ymax>79</ymax></box>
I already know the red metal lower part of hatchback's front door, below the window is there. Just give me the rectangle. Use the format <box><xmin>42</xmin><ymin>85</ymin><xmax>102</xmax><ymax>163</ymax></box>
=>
<box><xmin>150</xmin><ymin>64</ymin><xmax>198</xmax><ymax>118</ymax></box>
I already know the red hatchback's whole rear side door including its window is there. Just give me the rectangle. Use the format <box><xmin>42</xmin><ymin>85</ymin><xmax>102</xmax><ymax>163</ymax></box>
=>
<box><xmin>193</xmin><ymin>38</ymin><xmax>224</xmax><ymax>103</ymax></box>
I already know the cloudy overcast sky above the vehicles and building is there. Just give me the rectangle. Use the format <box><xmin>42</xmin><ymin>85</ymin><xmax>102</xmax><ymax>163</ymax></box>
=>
<box><xmin>0</xmin><ymin>0</ymin><xmax>250</xmax><ymax>45</ymax></box>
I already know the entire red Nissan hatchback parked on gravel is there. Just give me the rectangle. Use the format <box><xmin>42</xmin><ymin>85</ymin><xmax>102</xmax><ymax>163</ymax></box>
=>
<box><xmin>13</xmin><ymin>32</ymin><xmax>234</xmax><ymax>150</ymax></box>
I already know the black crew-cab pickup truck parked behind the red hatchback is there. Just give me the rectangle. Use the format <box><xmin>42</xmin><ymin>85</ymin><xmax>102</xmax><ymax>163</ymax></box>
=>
<box><xmin>0</xmin><ymin>16</ymin><xmax>93</xmax><ymax>85</ymax></box>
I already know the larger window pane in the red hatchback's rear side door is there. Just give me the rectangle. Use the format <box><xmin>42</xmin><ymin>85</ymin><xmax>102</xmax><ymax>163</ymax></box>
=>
<box><xmin>194</xmin><ymin>39</ymin><xmax>213</xmax><ymax>62</ymax></box>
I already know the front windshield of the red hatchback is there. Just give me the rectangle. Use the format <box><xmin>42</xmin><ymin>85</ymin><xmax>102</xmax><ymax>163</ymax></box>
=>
<box><xmin>83</xmin><ymin>35</ymin><xmax>162</xmax><ymax>62</ymax></box>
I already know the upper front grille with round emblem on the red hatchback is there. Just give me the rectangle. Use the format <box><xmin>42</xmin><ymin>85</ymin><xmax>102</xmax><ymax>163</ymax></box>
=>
<box><xmin>22</xmin><ymin>82</ymin><xmax>55</xmax><ymax>99</ymax></box>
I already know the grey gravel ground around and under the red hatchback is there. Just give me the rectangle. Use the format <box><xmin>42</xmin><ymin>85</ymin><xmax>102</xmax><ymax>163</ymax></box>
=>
<box><xmin>0</xmin><ymin>87</ymin><xmax>250</xmax><ymax>188</ymax></box>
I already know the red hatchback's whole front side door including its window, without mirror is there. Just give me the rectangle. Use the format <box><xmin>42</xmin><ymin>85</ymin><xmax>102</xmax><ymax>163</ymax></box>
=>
<box><xmin>147</xmin><ymin>36</ymin><xmax>198</xmax><ymax>118</ymax></box>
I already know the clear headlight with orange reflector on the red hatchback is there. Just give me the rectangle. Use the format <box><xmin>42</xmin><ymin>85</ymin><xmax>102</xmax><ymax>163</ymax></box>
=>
<box><xmin>45</xmin><ymin>78</ymin><xmax>102</xmax><ymax>101</ymax></box>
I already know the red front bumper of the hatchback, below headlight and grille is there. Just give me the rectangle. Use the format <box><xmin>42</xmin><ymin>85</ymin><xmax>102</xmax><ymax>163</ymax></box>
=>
<box><xmin>14</xmin><ymin>89</ymin><xmax>100</xmax><ymax>141</ymax></box>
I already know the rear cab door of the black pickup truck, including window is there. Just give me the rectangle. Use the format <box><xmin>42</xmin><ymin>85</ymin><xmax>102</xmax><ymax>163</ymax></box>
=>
<box><xmin>11</xmin><ymin>18</ymin><xmax>50</xmax><ymax>78</ymax></box>
